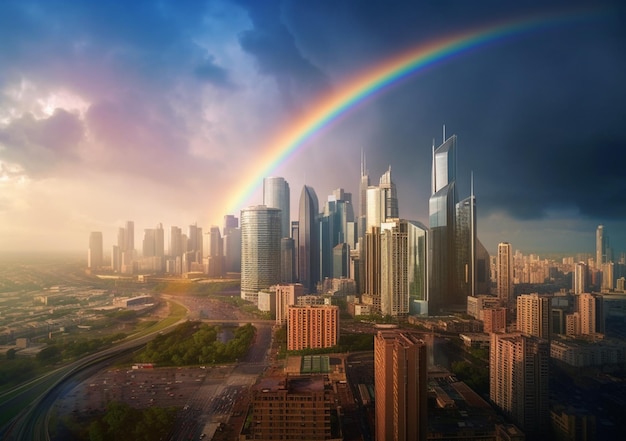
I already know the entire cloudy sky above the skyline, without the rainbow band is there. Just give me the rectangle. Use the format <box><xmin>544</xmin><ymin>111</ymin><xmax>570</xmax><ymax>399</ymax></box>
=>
<box><xmin>0</xmin><ymin>0</ymin><xmax>626</xmax><ymax>254</ymax></box>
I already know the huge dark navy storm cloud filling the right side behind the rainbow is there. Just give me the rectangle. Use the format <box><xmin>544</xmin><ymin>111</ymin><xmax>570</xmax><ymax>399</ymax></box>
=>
<box><xmin>272</xmin><ymin>1</ymin><xmax>626</xmax><ymax>227</ymax></box>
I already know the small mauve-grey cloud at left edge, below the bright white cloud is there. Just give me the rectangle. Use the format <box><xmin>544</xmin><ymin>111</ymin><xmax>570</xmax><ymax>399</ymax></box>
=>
<box><xmin>0</xmin><ymin>109</ymin><xmax>84</xmax><ymax>176</ymax></box>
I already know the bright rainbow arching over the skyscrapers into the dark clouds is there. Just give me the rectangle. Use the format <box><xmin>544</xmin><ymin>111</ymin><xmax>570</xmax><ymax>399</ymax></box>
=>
<box><xmin>226</xmin><ymin>11</ymin><xmax>590</xmax><ymax>213</ymax></box>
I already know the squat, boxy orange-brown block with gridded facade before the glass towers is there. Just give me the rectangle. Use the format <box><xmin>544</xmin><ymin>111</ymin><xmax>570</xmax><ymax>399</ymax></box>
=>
<box><xmin>287</xmin><ymin>305</ymin><xmax>339</xmax><ymax>351</ymax></box>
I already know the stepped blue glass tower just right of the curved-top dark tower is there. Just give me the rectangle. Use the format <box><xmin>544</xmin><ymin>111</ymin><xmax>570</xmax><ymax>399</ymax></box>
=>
<box><xmin>320</xmin><ymin>188</ymin><xmax>354</xmax><ymax>279</ymax></box>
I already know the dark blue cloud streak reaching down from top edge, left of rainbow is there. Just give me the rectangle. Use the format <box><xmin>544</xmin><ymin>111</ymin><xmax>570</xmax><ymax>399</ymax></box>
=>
<box><xmin>230</xmin><ymin>0</ymin><xmax>329</xmax><ymax>107</ymax></box>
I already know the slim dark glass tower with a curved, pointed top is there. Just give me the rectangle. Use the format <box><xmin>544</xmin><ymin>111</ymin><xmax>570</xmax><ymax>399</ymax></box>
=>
<box><xmin>298</xmin><ymin>185</ymin><xmax>320</xmax><ymax>293</ymax></box>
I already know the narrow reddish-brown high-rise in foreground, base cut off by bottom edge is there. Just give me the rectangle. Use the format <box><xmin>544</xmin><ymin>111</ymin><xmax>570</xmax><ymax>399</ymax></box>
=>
<box><xmin>374</xmin><ymin>331</ymin><xmax>428</xmax><ymax>441</ymax></box>
